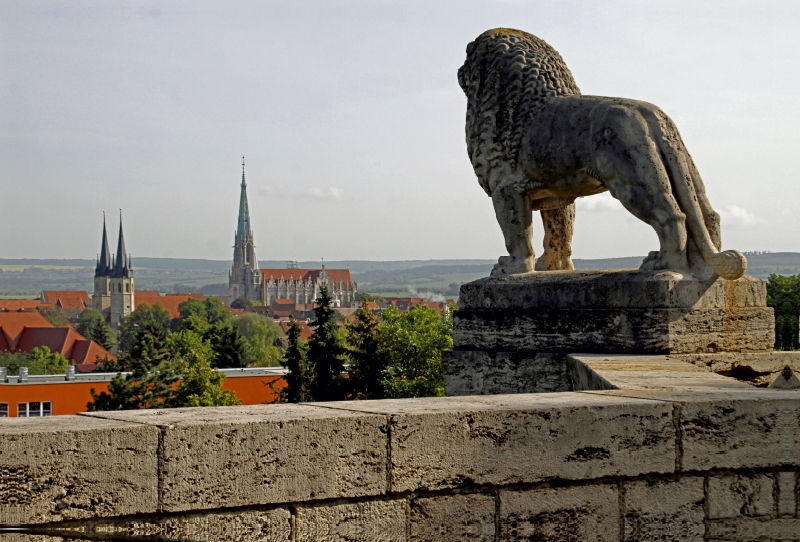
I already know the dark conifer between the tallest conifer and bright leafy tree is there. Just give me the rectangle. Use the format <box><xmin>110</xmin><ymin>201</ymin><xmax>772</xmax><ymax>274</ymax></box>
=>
<box><xmin>347</xmin><ymin>296</ymin><xmax>386</xmax><ymax>399</ymax></box>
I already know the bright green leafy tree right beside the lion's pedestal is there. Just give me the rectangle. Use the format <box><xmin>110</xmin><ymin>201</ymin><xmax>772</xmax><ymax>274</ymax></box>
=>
<box><xmin>380</xmin><ymin>305</ymin><xmax>453</xmax><ymax>397</ymax></box>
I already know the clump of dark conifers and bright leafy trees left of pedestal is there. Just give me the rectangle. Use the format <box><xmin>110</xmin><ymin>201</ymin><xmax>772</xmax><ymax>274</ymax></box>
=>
<box><xmin>281</xmin><ymin>286</ymin><xmax>453</xmax><ymax>403</ymax></box>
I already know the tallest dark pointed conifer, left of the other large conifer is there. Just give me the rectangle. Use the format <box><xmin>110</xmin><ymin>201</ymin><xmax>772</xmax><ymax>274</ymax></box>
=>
<box><xmin>307</xmin><ymin>284</ymin><xmax>347</xmax><ymax>401</ymax></box>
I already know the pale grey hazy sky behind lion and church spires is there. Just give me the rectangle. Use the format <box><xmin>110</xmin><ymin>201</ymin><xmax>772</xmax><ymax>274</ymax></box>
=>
<box><xmin>0</xmin><ymin>0</ymin><xmax>800</xmax><ymax>261</ymax></box>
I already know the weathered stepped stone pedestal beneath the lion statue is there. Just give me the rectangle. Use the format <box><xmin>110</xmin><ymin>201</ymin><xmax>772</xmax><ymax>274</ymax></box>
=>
<box><xmin>443</xmin><ymin>269</ymin><xmax>775</xmax><ymax>395</ymax></box>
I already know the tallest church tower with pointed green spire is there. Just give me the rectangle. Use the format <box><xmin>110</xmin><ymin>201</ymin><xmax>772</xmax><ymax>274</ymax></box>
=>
<box><xmin>228</xmin><ymin>156</ymin><xmax>261</xmax><ymax>303</ymax></box>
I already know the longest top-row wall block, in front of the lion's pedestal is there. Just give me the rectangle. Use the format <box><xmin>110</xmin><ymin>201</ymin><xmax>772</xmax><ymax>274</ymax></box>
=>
<box><xmin>316</xmin><ymin>393</ymin><xmax>675</xmax><ymax>492</ymax></box>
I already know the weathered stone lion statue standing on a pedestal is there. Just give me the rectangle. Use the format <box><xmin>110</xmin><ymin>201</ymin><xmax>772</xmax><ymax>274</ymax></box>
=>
<box><xmin>458</xmin><ymin>28</ymin><xmax>747</xmax><ymax>280</ymax></box>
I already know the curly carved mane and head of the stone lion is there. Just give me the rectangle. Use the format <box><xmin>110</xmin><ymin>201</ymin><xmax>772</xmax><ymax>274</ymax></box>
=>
<box><xmin>458</xmin><ymin>28</ymin><xmax>581</xmax><ymax>195</ymax></box>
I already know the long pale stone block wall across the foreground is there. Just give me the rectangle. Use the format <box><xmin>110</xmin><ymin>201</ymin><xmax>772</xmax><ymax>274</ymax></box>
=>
<box><xmin>0</xmin><ymin>366</ymin><xmax>800</xmax><ymax>541</ymax></box>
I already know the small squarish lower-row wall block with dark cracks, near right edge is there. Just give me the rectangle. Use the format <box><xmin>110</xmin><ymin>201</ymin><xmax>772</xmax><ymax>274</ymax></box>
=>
<box><xmin>708</xmin><ymin>474</ymin><xmax>775</xmax><ymax>519</ymax></box>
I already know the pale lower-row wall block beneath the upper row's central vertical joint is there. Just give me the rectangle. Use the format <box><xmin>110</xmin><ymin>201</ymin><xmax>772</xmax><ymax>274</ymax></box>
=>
<box><xmin>294</xmin><ymin>499</ymin><xmax>408</xmax><ymax>542</ymax></box>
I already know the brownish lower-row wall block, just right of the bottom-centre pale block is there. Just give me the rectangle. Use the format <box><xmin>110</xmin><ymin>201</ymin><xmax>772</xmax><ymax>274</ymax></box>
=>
<box><xmin>411</xmin><ymin>494</ymin><xmax>495</xmax><ymax>542</ymax></box>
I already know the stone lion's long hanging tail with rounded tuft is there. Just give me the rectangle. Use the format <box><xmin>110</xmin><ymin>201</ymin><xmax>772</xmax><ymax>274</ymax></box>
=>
<box><xmin>651</xmin><ymin>110</ymin><xmax>747</xmax><ymax>280</ymax></box>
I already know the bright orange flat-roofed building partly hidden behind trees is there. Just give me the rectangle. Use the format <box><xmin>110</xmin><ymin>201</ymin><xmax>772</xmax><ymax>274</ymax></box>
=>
<box><xmin>0</xmin><ymin>367</ymin><xmax>286</xmax><ymax>418</ymax></box>
